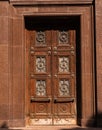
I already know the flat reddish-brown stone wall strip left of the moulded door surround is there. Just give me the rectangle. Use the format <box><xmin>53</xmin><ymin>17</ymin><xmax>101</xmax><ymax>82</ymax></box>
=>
<box><xmin>0</xmin><ymin>2</ymin><xmax>9</xmax><ymax>125</ymax></box>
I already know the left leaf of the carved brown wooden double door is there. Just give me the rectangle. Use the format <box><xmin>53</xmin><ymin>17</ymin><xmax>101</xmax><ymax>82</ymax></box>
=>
<box><xmin>29</xmin><ymin>30</ymin><xmax>52</xmax><ymax>125</ymax></box>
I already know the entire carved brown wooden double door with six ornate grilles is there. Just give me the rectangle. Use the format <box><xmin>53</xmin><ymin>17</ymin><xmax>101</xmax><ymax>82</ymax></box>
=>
<box><xmin>27</xmin><ymin>27</ymin><xmax>76</xmax><ymax>125</ymax></box>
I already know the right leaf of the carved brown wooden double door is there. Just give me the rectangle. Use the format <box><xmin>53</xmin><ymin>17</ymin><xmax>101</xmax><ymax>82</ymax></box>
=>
<box><xmin>52</xmin><ymin>30</ymin><xmax>76</xmax><ymax>125</ymax></box>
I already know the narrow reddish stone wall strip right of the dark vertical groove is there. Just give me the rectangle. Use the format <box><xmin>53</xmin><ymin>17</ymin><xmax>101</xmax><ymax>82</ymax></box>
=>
<box><xmin>95</xmin><ymin>0</ymin><xmax>102</xmax><ymax>126</ymax></box>
